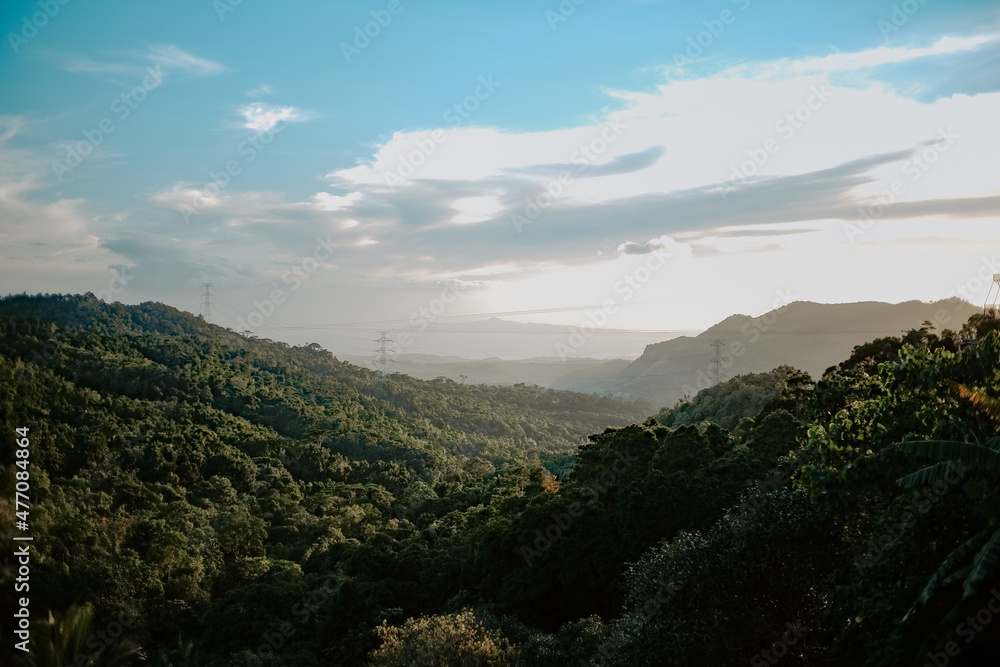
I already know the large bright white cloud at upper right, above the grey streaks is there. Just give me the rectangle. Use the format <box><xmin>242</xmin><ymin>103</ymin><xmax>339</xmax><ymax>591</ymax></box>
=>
<box><xmin>327</xmin><ymin>35</ymin><xmax>1000</xmax><ymax>230</ymax></box>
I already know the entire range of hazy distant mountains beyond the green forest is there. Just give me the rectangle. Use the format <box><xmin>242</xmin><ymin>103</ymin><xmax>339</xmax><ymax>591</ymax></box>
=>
<box><xmin>341</xmin><ymin>299</ymin><xmax>980</xmax><ymax>407</ymax></box>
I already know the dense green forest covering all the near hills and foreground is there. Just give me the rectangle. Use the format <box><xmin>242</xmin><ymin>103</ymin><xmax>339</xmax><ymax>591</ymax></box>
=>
<box><xmin>0</xmin><ymin>296</ymin><xmax>1000</xmax><ymax>667</ymax></box>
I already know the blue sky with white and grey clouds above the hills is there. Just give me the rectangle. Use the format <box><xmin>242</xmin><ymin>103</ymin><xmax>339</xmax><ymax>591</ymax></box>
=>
<box><xmin>0</xmin><ymin>0</ymin><xmax>1000</xmax><ymax>356</ymax></box>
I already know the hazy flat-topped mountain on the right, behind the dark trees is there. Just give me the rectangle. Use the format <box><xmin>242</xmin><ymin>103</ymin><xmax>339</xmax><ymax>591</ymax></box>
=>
<box><xmin>574</xmin><ymin>299</ymin><xmax>981</xmax><ymax>407</ymax></box>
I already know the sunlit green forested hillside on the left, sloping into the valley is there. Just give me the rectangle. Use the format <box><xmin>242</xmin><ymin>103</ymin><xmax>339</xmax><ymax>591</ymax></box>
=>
<box><xmin>0</xmin><ymin>295</ymin><xmax>649</xmax><ymax>664</ymax></box>
